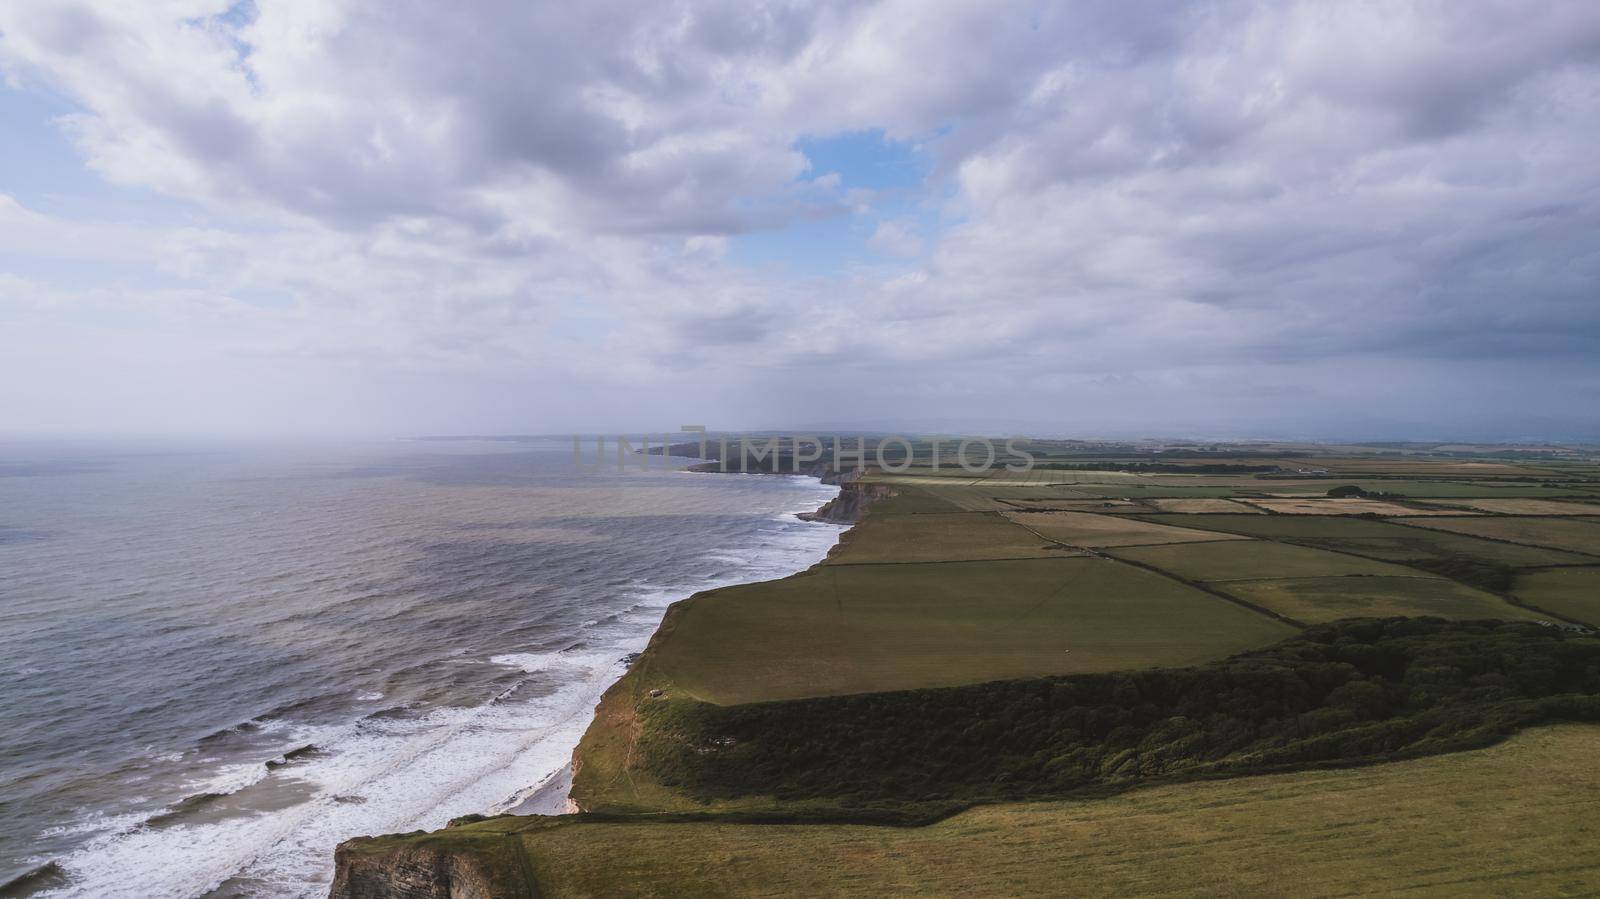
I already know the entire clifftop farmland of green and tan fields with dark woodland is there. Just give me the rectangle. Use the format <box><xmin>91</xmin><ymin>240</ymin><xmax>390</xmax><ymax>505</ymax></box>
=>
<box><xmin>340</xmin><ymin>446</ymin><xmax>1600</xmax><ymax>896</ymax></box>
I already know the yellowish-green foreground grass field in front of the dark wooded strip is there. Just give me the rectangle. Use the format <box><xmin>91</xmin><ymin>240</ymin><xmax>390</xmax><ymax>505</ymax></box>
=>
<box><xmin>457</xmin><ymin>725</ymin><xmax>1600</xmax><ymax>897</ymax></box>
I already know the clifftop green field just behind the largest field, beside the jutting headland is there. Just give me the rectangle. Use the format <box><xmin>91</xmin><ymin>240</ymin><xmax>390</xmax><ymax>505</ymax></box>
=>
<box><xmin>827</xmin><ymin>512</ymin><xmax>1075</xmax><ymax>565</ymax></box>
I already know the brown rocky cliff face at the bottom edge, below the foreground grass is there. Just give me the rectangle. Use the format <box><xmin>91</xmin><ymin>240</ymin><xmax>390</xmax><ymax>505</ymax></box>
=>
<box><xmin>328</xmin><ymin>827</ymin><xmax>539</xmax><ymax>899</ymax></box>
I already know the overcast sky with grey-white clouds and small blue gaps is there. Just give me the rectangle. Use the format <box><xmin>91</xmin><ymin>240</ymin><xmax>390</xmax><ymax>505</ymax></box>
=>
<box><xmin>0</xmin><ymin>0</ymin><xmax>1600</xmax><ymax>438</ymax></box>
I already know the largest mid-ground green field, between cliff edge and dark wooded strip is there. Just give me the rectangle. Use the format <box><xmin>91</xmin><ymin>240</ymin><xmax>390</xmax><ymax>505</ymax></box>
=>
<box><xmin>654</xmin><ymin>557</ymin><xmax>1293</xmax><ymax>704</ymax></box>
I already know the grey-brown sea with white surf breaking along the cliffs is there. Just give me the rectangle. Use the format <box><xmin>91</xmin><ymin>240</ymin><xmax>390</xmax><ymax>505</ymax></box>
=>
<box><xmin>0</xmin><ymin>440</ymin><xmax>840</xmax><ymax>897</ymax></box>
